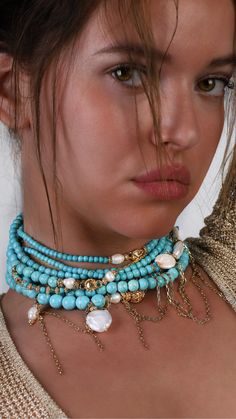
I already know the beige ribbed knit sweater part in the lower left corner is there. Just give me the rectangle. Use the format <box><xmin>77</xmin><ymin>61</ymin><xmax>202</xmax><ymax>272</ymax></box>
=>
<box><xmin>0</xmin><ymin>309</ymin><xmax>66</xmax><ymax>419</ymax></box>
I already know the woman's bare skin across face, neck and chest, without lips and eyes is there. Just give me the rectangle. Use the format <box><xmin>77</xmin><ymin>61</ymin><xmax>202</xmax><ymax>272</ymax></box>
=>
<box><xmin>1</xmin><ymin>0</ymin><xmax>236</xmax><ymax>417</ymax></box>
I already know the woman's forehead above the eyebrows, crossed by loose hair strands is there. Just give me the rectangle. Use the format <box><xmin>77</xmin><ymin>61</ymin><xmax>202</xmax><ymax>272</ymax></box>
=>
<box><xmin>77</xmin><ymin>0</ymin><xmax>235</xmax><ymax>65</ymax></box>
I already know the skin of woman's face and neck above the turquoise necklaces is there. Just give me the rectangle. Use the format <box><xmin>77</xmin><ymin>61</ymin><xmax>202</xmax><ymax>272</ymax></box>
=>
<box><xmin>15</xmin><ymin>1</ymin><xmax>234</xmax><ymax>255</ymax></box>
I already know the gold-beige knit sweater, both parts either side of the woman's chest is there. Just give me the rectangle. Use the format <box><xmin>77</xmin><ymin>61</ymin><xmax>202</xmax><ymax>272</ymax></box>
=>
<box><xmin>0</xmin><ymin>162</ymin><xmax>236</xmax><ymax>419</ymax></box>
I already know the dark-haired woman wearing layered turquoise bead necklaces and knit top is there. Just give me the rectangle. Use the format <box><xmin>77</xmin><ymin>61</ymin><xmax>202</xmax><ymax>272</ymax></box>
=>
<box><xmin>0</xmin><ymin>0</ymin><xmax>236</xmax><ymax>418</ymax></box>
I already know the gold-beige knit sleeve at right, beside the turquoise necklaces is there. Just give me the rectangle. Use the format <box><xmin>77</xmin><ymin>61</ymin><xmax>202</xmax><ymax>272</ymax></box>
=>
<box><xmin>187</xmin><ymin>150</ymin><xmax>236</xmax><ymax>311</ymax></box>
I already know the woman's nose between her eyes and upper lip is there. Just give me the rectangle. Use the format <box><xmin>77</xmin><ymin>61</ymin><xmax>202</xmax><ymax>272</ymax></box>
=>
<box><xmin>153</xmin><ymin>85</ymin><xmax>199</xmax><ymax>151</ymax></box>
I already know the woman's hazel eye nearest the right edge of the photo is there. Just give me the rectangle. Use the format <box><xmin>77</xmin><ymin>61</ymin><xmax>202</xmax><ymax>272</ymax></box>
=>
<box><xmin>197</xmin><ymin>77</ymin><xmax>234</xmax><ymax>96</ymax></box>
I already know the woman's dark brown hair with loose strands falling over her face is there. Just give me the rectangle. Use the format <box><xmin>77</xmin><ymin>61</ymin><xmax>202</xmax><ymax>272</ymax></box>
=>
<box><xmin>0</xmin><ymin>0</ymin><xmax>235</xmax><ymax>247</ymax></box>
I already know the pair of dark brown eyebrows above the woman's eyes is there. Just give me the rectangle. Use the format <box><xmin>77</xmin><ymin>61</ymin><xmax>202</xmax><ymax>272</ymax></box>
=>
<box><xmin>93</xmin><ymin>43</ymin><xmax>236</xmax><ymax>68</ymax></box>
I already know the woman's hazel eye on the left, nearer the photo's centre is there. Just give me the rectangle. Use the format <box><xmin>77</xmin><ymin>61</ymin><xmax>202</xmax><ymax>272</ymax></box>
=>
<box><xmin>110</xmin><ymin>64</ymin><xmax>145</xmax><ymax>88</ymax></box>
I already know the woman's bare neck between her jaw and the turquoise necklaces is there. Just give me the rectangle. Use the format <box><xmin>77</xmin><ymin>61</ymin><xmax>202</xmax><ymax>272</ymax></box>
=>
<box><xmin>24</xmin><ymin>202</ymin><xmax>150</xmax><ymax>256</ymax></box>
